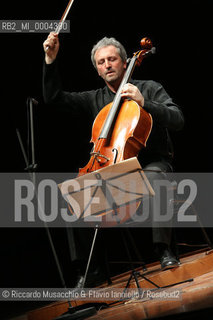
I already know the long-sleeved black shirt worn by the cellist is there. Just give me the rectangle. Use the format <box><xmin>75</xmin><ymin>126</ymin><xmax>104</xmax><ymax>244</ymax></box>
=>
<box><xmin>43</xmin><ymin>61</ymin><xmax>184</xmax><ymax>166</ymax></box>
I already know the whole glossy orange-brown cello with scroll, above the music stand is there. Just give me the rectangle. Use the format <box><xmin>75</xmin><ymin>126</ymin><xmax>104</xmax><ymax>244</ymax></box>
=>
<box><xmin>79</xmin><ymin>38</ymin><xmax>155</xmax><ymax>176</ymax></box>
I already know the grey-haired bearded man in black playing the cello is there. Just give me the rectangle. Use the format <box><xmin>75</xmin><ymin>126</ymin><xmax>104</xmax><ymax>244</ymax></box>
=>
<box><xmin>43</xmin><ymin>33</ymin><xmax>184</xmax><ymax>282</ymax></box>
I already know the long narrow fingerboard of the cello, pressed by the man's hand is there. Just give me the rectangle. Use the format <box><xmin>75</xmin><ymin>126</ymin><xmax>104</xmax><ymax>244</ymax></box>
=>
<box><xmin>99</xmin><ymin>56</ymin><xmax>137</xmax><ymax>139</ymax></box>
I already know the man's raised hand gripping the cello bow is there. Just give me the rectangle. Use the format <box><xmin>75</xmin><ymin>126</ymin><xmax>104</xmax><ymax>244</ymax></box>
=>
<box><xmin>43</xmin><ymin>32</ymin><xmax>59</xmax><ymax>64</ymax></box>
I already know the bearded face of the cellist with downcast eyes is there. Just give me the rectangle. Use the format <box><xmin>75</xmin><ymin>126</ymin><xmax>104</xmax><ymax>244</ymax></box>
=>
<box><xmin>95</xmin><ymin>45</ymin><xmax>126</xmax><ymax>85</ymax></box>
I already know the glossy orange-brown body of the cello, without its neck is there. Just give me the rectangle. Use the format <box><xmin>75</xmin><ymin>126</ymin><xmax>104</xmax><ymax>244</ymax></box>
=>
<box><xmin>79</xmin><ymin>99</ymin><xmax>152</xmax><ymax>176</ymax></box>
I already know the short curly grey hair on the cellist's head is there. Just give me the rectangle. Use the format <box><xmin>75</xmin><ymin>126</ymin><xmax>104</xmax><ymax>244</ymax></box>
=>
<box><xmin>91</xmin><ymin>37</ymin><xmax>127</xmax><ymax>69</ymax></box>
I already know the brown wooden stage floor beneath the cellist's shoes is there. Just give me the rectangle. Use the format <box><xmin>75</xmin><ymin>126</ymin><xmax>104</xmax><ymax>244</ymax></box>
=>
<box><xmin>24</xmin><ymin>249</ymin><xmax>213</xmax><ymax>320</ymax></box>
